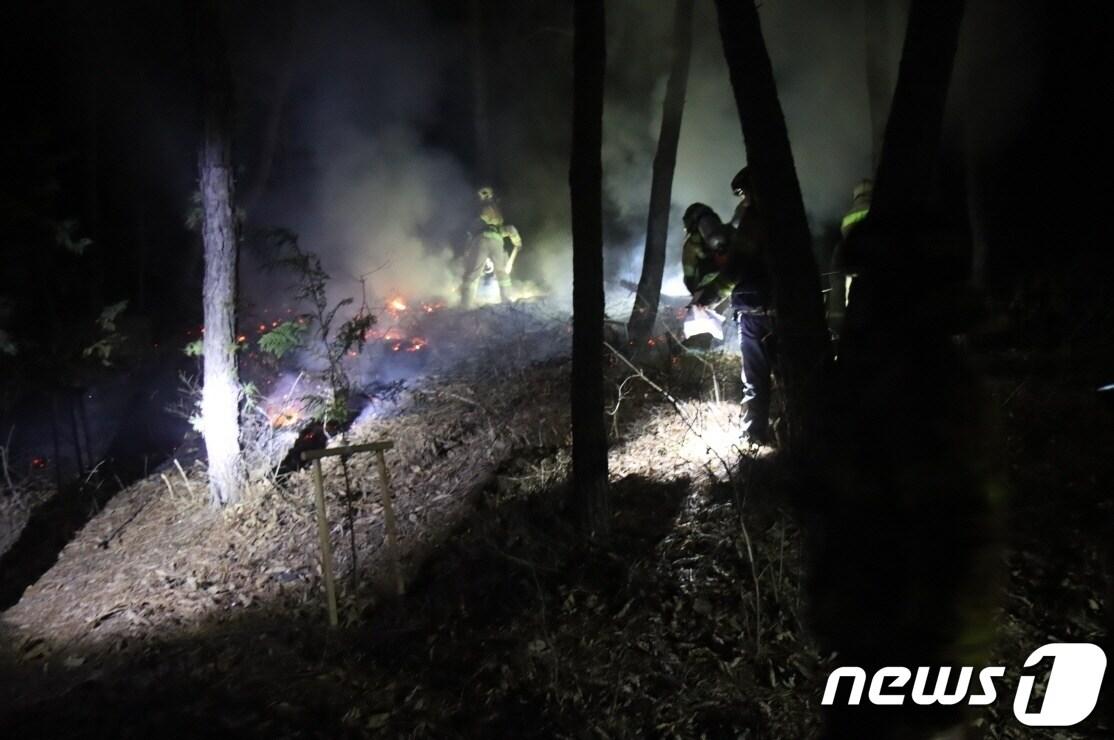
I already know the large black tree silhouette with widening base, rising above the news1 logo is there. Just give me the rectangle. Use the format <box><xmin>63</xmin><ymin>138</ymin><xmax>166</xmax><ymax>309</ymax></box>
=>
<box><xmin>808</xmin><ymin>5</ymin><xmax>1001</xmax><ymax>738</ymax></box>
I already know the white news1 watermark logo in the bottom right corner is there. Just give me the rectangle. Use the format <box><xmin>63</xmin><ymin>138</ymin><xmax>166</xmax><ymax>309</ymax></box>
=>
<box><xmin>820</xmin><ymin>642</ymin><xmax>1106</xmax><ymax>727</ymax></box>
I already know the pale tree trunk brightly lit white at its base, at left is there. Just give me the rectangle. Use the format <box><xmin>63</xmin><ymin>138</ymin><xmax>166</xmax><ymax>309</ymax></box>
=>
<box><xmin>198</xmin><ymin>0</ymin><xmax>243</xmax><ymax>506</ymax></box>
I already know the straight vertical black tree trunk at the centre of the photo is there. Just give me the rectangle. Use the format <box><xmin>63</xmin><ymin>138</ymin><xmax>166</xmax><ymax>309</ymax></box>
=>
<box><xmin>568</xmin><ymin>0</ymin><xmax>610</xmax><ymax>541</ymax></box>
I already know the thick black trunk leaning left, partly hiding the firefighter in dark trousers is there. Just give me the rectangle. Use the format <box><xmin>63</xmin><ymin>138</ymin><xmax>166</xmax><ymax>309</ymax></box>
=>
<box><xmin>715</xmin><ymin>0</ymin><xmax>830</xmax><ymax>459</ymax></box>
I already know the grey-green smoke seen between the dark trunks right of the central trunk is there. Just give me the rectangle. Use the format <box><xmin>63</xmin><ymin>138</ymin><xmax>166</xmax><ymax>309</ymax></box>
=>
<box><xmin>604</xmin><ymin>0</ymin><xmax>871</xmax><ymax>294</ymax></box>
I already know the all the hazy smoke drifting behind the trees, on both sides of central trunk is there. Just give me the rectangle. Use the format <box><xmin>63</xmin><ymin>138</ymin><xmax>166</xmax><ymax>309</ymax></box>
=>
<box><xmin>239</xmin><ymin>0</ymin><xmax>1038</xmax><ymax>320</ymax></box>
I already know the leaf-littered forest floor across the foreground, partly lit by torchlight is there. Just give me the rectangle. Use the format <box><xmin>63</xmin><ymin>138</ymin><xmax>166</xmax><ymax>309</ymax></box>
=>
<box><xmin>0</xmin><ymin>303</ymin><xmax>1112</xmax><ymax>738</ymax></box>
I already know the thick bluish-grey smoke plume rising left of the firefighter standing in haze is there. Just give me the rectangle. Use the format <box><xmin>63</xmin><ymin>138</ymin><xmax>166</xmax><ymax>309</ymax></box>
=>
<box><xmin>247</xmin><ymin>2</ymin><xmax>473</xmax><ymax>312</ymax></box>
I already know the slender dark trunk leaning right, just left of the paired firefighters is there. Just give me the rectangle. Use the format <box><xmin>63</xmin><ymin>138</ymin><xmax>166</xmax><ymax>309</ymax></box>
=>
<box><xmin>627</xmin><ymin>0</ymin><xmax>695</xmax><ymax>347</ymax></box>
